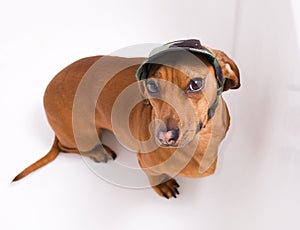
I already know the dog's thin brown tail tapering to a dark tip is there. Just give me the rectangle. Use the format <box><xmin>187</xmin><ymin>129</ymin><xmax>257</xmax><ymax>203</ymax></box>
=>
<box><xmin>12</xmin><ymin>137</ymin><xmax>60</xmax><ymax>182</ymax></box>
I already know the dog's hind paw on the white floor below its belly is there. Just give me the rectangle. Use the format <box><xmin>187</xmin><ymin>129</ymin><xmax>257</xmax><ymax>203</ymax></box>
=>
<box><xmin>82</xmin><ymin>145</ymin><xmax>117</xmax><ymax>163</ymax></box>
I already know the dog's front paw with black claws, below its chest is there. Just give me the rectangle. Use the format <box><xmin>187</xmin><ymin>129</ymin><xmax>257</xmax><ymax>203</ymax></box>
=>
<box><xmin>152</xmin><ymin>178</ymin><xmax>179</xmax><ymax>199</ymax></box>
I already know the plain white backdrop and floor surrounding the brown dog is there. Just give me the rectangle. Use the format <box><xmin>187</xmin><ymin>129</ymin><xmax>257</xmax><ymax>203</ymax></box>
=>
<box><xmin>0</xmin><ymin>0</ymin><xmax>300</xmax><ymax>230</ymax></box>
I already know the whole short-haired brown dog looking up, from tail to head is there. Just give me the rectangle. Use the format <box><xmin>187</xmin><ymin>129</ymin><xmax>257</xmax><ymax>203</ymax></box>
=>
<box><xmin>13</xmin><ymin>39</ymin><xmax>240</xmax><ymax>198</ymax></box>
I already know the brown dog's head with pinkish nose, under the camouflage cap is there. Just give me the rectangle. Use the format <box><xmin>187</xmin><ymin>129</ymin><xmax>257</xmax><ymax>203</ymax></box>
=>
<box><xmin>137</xmin><ymin>40</ymin><xmax>240</xmax><ymax>147</ymax></box>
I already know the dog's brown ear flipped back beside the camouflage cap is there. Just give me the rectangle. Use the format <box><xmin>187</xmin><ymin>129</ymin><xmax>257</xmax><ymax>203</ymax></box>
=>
<box><xmin>208</xmin><ymin>48</ymin><xmax>241</xmax><ymax>91</ymax></box>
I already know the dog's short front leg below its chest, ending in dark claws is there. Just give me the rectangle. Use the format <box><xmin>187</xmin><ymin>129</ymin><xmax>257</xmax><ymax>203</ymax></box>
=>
<box><xmin>147</xmin><ymin>174</ymin><xmax>179</xmax><ymax>199</ymax></box>
